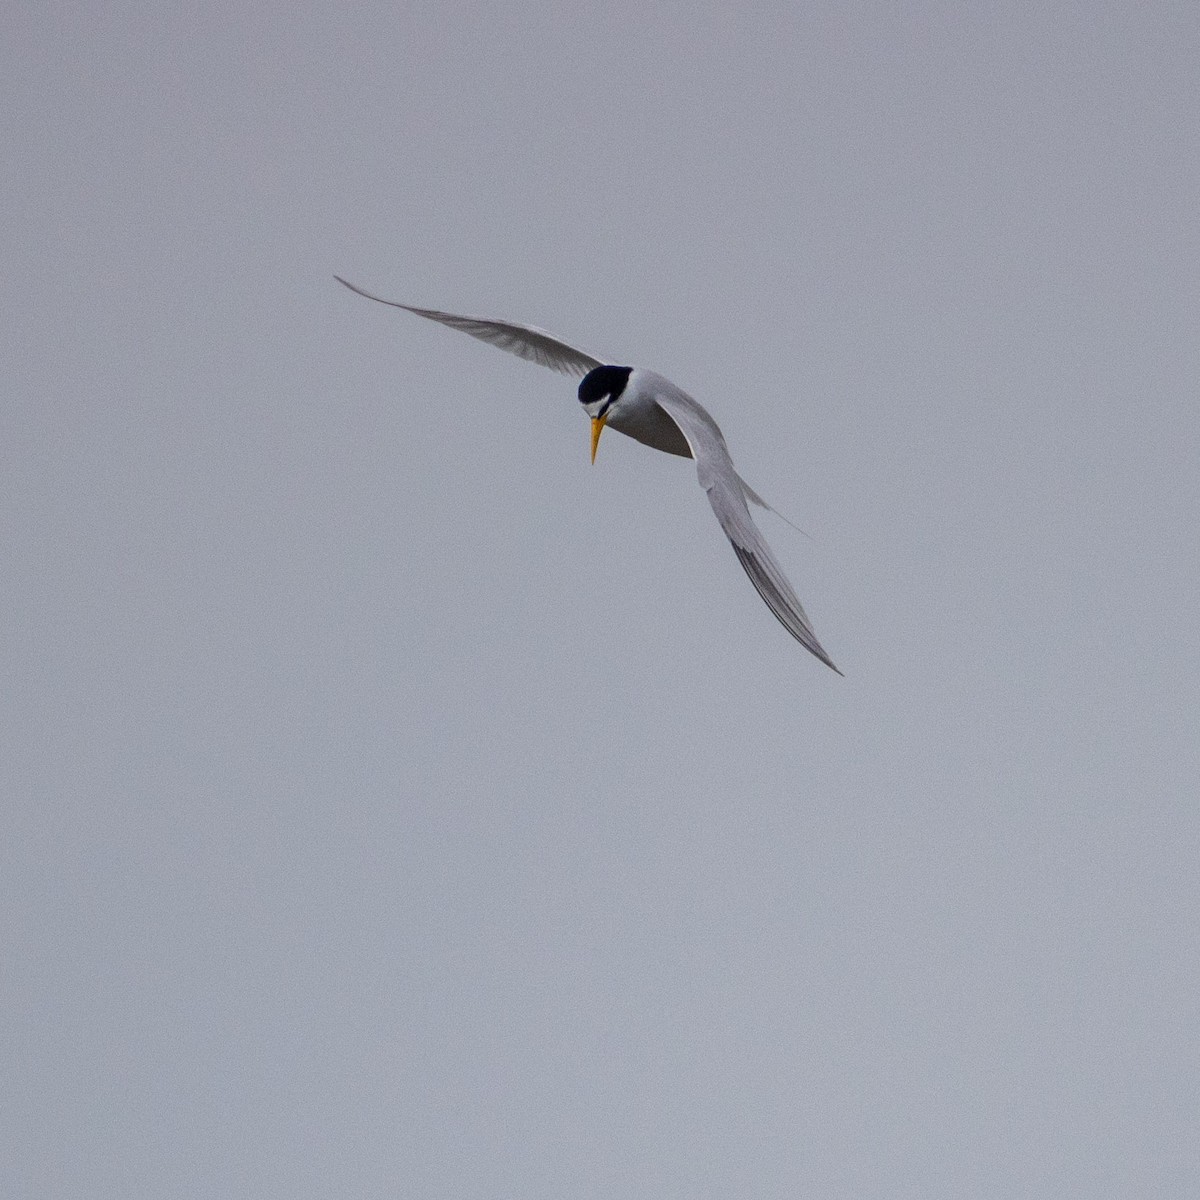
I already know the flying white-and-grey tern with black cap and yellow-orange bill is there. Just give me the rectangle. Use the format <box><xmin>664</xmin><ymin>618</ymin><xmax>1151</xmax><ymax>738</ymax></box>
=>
<box><xmin>334</xmin><ymin>275</ymin><xmax>841</xmax><ymax>674</ymax></box>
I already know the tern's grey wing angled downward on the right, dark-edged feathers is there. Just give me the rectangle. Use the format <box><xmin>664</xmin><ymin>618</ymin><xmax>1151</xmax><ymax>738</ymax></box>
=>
<box><xmin>654</xmin><ymin>379</ymin><xmax>841</xmax><ymax>674</ymax></box>
